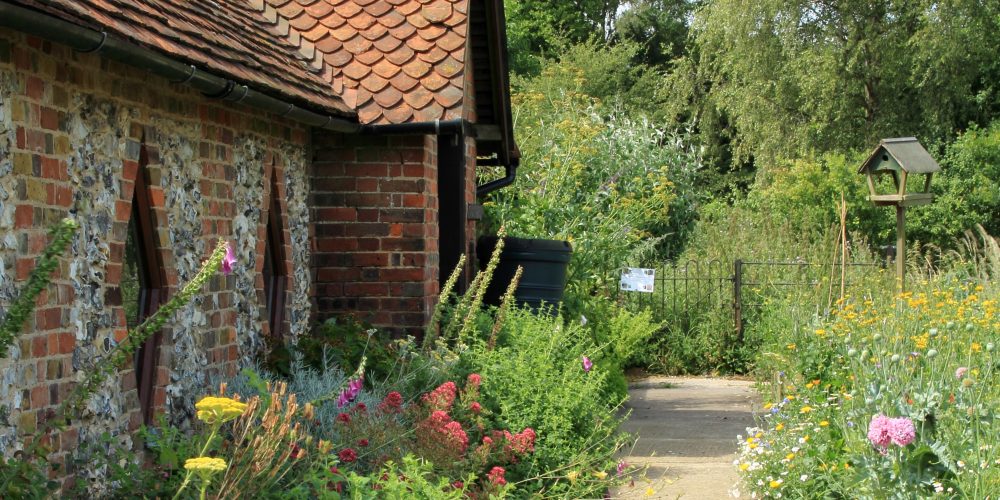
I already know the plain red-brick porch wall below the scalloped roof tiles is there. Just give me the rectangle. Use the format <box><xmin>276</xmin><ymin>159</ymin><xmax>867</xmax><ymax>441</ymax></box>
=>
<box><xmin>312</xmin><ymin>131</ymin><xmax>438</xmax><ymax>334</ymax></box>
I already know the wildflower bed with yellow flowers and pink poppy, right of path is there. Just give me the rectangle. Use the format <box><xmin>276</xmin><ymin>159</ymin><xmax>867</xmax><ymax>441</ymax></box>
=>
<box><xmin>736</xmin><ymin>280</ymin><xmax>1000</xmax><ymax>498</ymax></box>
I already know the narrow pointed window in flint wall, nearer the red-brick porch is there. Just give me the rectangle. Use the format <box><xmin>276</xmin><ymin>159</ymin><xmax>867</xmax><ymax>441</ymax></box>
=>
<box><xmin>263</xmin><ymin>174</ymin><xmax>288</xmax><ymax>341</ymax></box>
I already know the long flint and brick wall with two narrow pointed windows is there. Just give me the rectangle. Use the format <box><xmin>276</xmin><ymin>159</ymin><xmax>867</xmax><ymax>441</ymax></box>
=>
<box><xmin>0</xmin><ymin>30</ymin><xmax>312</xmax><ymax>488</ymax></box>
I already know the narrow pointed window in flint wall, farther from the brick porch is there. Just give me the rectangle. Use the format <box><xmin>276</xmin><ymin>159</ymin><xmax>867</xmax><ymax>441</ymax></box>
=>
<box><xmin>121</xmin><ymin>151</ymin><xmax>166</xmax><ymax>425</ymax></box>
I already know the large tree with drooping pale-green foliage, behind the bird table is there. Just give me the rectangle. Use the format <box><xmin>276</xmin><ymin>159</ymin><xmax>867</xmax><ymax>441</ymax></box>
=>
<box><xmin>669</xmin><ymin>0</ymin><xmax>1000</xmax><ymax>163</ymax></box>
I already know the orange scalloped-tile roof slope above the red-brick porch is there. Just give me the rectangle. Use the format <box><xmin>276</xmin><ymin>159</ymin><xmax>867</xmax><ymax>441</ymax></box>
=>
<box><xmin>264</xmin><ymin>0</ymin><xmax>469</xmax><ymax>124</ymax></box>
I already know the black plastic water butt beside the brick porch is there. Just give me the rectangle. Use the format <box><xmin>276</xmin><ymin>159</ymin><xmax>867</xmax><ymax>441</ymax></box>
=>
<box><xmin>476</xmin><ymin>236</ymin><xmax>573</xmax><ymax>311</ymax></box>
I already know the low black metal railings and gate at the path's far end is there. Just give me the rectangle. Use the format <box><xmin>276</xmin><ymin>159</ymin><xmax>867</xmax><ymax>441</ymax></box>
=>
<box><xmin>619</xmin><ymin>259</ymin><xmax>884</xmax><ymax>343</ymax></box>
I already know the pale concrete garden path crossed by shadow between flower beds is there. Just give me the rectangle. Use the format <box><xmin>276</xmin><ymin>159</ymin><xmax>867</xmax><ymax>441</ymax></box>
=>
<box><xmin>615</xmin><ymin>377</ymin><xmax>759</xmax><ymax>500</ymax></box>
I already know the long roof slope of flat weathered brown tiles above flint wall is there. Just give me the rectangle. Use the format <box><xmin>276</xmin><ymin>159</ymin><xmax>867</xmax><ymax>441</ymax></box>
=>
<box><xmin>18</xmin><ymin>0</ymin><xmax>360</xmax><ymax>116</ymax></box>
